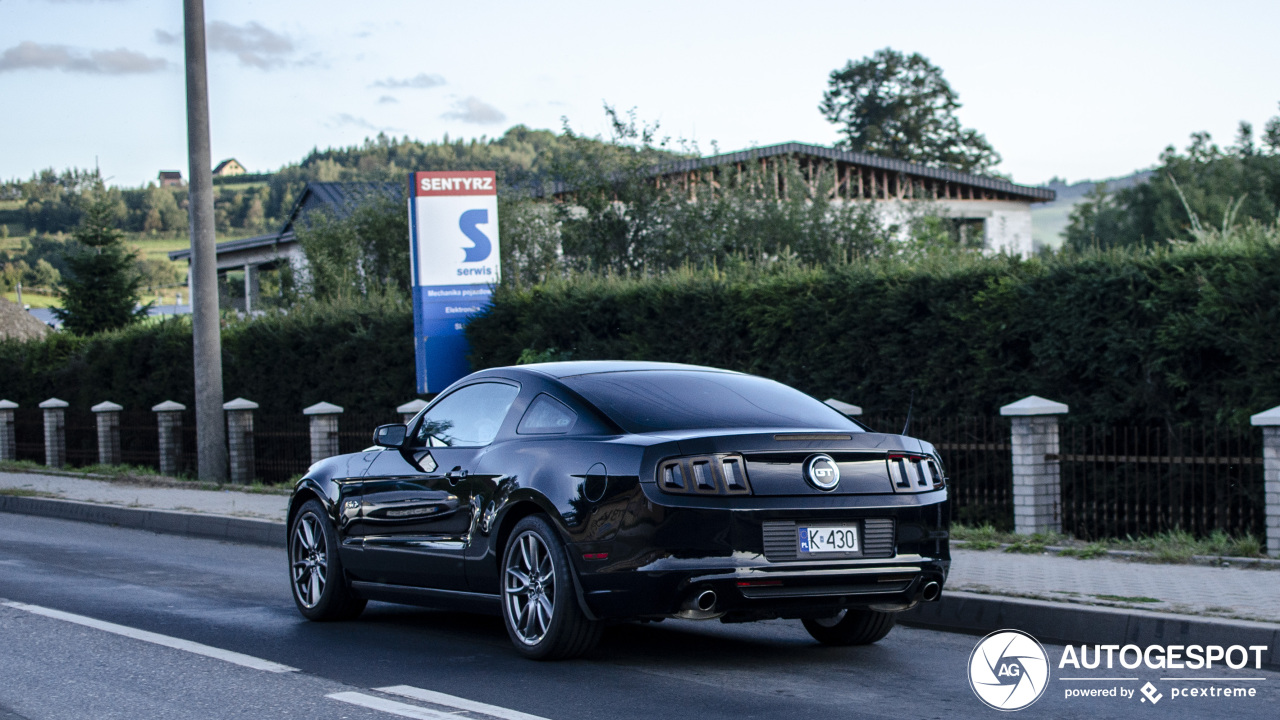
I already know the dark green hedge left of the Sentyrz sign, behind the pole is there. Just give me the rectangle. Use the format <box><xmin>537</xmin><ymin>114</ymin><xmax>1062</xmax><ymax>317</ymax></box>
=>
<box><xmin>0</xmin><ymin>302</ymin><xmax>415</xmax><ymax>414</ymax></box>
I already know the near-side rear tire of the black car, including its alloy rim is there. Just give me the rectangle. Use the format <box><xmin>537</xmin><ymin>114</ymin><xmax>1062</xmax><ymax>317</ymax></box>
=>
<box><xmin>500</xmin><ymin>515</ymin><xmax>602</xmax><ymax>660</ymax></box>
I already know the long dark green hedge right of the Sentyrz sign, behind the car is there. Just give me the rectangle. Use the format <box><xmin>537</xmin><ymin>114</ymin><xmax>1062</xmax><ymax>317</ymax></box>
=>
<box><xmin>467</xmin><ymin>242</ymin><xmax>1280</xmax><ymax>427</ymax></box>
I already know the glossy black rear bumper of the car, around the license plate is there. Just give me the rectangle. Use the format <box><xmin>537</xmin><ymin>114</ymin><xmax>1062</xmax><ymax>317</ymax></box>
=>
<box><xmin>570</xmin><ymin>491</ymin><xmax>951</xmax><ymax>620</ymax></box>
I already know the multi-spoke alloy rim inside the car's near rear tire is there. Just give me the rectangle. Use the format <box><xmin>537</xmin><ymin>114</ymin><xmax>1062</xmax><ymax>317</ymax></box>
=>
<box><xmin>503</xmin><ymin>532</ymin><xmax>556</xmax><ymax>644</ymax></box>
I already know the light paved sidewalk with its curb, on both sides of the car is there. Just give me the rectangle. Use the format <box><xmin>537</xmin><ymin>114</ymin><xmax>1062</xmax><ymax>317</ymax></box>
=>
<box><xmin>0</xmin><ymin>473</ymin><xmax>1280</xmax><ymax>665</ymax></box>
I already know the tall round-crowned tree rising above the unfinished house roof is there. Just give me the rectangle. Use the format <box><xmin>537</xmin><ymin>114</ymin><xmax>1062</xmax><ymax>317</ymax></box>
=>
<box><xmin>818</xmin><ymin>47</ymin><xmax>1000</xmax><ymax>173</ymax></box>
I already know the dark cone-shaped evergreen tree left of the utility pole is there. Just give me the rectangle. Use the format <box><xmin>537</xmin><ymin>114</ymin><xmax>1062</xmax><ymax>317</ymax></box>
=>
<box><xmin>54</xmin><ymin>191</ymin><xmax>151</xmax><ymax>336</ymax></box>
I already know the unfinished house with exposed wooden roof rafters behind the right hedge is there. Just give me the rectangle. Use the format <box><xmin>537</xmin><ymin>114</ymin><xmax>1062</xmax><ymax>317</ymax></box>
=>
<box><xmin>553</xmin><ymin>142</ymin><xmax>1055</xmax><ymax>256</ymax></box>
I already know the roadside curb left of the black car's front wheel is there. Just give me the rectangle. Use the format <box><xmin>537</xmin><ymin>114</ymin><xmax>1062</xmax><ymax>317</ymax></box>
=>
<box><xmin>0</xmin><ymin>495</ymin><xmax>285</xmax><ymax>547</ymax></box>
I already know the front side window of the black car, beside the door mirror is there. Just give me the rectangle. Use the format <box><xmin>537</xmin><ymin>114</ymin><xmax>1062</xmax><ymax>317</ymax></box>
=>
<box><xmin>415</xmin><ymin>383</ymin><xmax>520</xmax><ymax>447</ymax></box>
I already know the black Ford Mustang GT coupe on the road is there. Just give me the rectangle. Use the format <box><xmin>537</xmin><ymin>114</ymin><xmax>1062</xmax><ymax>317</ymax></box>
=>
<box><xmin>288</xmin><ymin>363</ymin><xmax>950</xmax><ymax>659</ymax></box>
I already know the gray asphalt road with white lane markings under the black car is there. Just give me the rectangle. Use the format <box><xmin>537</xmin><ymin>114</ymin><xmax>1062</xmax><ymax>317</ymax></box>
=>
<box><xmin>0</xmin><ymin>514</ymin><xmax>1280</xmax><ymax>720</ymax></box>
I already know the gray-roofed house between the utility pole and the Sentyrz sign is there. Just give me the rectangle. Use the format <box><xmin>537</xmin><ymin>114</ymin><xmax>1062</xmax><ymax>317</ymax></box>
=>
<box><xmin>169</xmin><ymin>182</ymin><xmax>404</xmax><ymax>311</ymax></box>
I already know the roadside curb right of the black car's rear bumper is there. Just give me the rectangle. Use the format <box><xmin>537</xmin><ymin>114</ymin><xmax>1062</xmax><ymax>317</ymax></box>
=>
<box><xmin>897</xmin><ymin>592</ymin><xmax>1280</xmax><ymax>667</ymax></box>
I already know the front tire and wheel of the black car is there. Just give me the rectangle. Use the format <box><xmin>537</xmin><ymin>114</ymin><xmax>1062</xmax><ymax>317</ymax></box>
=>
<box><xmin>289</xmin><ymin>500</ymin><xmax>369</xmax><ymax>621</ymax></box>
